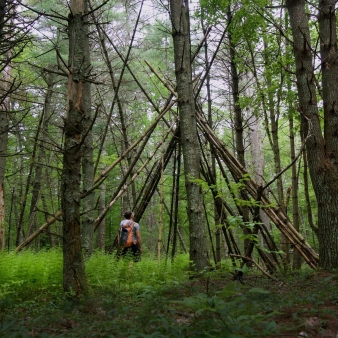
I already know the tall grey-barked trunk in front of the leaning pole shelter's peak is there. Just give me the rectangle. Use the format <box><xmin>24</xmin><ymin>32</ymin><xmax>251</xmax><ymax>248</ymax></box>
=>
<box><xmin>170</xmin><ymin>0</ymin><xmax>207</xmax><ymax>270</ymax></box>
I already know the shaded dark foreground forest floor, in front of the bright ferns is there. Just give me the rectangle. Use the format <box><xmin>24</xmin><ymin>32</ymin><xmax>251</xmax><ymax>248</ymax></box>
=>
<box><xmin>0</xmin><ymin>269</ymin><xmax>338</xmax><ymax>338</ymax></box>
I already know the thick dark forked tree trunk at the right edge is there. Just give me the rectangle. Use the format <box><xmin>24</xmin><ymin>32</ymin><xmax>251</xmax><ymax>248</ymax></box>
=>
<box><xmin>286</xmin><ymin>0</ymin><xmax>338</xmax><ymax>270</ymax></box>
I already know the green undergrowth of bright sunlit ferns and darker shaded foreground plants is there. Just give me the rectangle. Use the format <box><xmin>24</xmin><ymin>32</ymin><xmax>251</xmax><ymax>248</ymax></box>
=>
<box><xmin>0</xmin><ymin>250</ymin><xmax>338</xmax><ymax>338</ymax></box>
